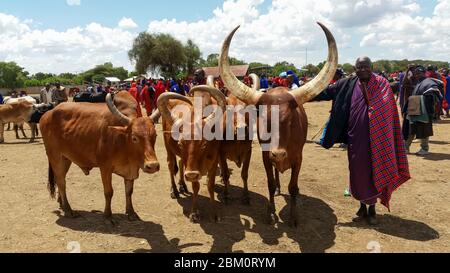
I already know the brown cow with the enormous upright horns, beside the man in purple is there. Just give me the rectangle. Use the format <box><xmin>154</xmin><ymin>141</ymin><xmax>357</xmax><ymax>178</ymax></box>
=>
<box><xmin>219</xmin><ymin>23</ymin><xmax>338</xmax><ymax>226</ymax></box>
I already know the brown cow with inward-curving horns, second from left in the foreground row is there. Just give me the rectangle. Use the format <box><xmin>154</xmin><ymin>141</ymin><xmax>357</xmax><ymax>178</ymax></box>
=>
<box><xmin>157</xmin><ymin>86</ymin><xmax>226</xmax><ymax>223</ymax></box>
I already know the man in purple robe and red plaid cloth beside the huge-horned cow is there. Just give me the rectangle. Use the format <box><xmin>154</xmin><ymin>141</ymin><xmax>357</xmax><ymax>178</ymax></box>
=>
<box><xmin>315</xmin><ymin>57</ymin><xmax>410</xmax><ymax>225</ymax></box>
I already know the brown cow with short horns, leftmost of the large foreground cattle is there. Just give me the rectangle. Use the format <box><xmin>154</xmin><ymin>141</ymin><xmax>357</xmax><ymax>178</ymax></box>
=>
<box><xmin>40</xmin><ymin>92</ymin><xmax>159</xmax><ymax>224</ymax></box>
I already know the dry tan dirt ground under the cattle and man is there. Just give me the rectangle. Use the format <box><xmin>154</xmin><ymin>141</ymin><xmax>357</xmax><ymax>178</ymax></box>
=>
<box><xmin>0</xmin><ymin>103</ymin><xmax>450</xmax><ymax>253</ymax></box>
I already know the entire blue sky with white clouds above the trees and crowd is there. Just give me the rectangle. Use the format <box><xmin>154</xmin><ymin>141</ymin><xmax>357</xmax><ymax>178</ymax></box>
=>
<box><xmin>0</xmin><ymin>0</ymin><xmax>450</xmax><ymax>73</ymax></box>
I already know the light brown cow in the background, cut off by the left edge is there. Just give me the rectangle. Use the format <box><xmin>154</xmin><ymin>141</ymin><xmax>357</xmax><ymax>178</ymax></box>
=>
<box><xmin>0</xmin><ymin>100</ymin><xmax>37</xmax><ymax>143</ymax></box>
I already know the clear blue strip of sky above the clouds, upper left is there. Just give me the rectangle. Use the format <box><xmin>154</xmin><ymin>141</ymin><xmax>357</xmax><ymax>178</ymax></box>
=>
<box><xmin>0</xmin><ymin>0</ymin><xmax>270</xmax><ymax>31</ymax></box>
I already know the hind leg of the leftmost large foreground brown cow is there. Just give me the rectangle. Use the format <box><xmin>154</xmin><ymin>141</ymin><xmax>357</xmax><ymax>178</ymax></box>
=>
<box><xmin>50</xmin><ymin>157</ymin><xmax>79</xmax><ymax>218</ymax></box>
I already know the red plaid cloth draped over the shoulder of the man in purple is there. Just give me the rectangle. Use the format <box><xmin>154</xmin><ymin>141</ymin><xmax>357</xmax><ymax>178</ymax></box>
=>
<box><xmin>367</xmin><ymin>74</ymin><xmax>411</xmax><ymax>210</ymax></box>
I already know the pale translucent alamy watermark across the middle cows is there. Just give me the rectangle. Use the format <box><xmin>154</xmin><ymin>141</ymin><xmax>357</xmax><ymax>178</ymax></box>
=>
<box><xmin>167</xmin><ymin>97</ymin><xmax>280</xmax><ymax>151</ymax></box>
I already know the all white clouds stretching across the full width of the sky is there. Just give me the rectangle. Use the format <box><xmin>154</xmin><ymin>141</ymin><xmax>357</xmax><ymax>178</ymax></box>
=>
<box><xmin>0</xmin><ymin>0</ymin><xmax>450</xmax><ymax>73</ymax></box>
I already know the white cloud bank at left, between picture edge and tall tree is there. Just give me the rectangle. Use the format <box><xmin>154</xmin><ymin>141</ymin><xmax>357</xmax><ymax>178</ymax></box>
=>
<box><xmin>0</xmin><ymin>14</ymin><xmax>137</xmax><ymax>73</ymax></box>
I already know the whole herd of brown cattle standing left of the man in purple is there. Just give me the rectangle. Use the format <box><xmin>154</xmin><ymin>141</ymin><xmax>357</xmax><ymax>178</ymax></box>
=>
<box><xmin>0</xmin><ymin>23</ymin><xmax>338</xmax><ymax>226</ymax></box>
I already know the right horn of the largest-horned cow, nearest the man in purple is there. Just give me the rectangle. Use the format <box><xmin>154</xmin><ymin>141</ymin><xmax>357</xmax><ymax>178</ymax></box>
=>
<box><xmin>290</xmin><ymin>22</ymin><xmax>338</xmax><ymax>105</ymax></box>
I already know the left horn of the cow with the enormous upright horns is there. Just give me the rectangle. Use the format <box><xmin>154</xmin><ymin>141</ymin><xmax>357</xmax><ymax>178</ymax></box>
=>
<box><xmin>219</xmin><ymin>26</ymin><xmax>262</xmax><ymax>104</ymax></box>
